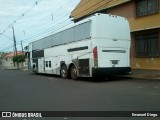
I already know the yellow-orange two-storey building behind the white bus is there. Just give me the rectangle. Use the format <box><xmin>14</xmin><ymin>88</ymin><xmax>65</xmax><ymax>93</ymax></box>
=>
<box><xmin>70</xmin><ymin>0</ymin><xmax>160</xmax><ymax>70</ymax></box>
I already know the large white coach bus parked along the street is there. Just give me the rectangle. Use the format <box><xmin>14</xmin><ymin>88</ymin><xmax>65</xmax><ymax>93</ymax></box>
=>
<box><xmin>29</xmin><ymin>13</ymin><xmax>131</xmax><ymax>79</ymax></box>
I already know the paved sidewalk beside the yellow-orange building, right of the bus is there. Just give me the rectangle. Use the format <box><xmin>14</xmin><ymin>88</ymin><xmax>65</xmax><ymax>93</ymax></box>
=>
<box><xmin>129</xmin><ymin>70</ymin><xmax>160</xmax><ymax>80</ymax></box>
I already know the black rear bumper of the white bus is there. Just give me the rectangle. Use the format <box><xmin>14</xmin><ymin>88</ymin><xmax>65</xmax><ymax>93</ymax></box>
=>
<box><xmin>92</xmin><ymin>67</ymin><xmax>131</xmax><ymax>77</ymax></box>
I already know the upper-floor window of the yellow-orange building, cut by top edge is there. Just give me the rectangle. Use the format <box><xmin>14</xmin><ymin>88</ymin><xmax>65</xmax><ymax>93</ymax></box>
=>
<box><xmin>136</xmin><ymin>0</ymin><xmax>159</xmax><ymax>16</ymax></box>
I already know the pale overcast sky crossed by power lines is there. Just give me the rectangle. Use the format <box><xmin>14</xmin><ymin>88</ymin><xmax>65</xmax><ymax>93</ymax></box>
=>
<box><xmin>0</xmin><ymin>0</ymin><xmax>80</xmax><ymax>52</ymax></box>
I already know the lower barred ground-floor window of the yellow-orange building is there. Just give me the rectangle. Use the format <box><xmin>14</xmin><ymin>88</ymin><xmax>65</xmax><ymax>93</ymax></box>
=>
<box><xmin>135</xmin><ymin>33</ymin><xmax>160</xmax><ymax>57</ymax></box>
